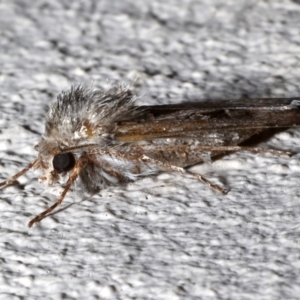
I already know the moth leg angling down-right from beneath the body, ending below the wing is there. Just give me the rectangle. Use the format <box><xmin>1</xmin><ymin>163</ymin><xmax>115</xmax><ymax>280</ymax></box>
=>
<box><xmin>141</xmin><ymin>155</ymin><xmax>228</xmax><ymax>195</ymax></box>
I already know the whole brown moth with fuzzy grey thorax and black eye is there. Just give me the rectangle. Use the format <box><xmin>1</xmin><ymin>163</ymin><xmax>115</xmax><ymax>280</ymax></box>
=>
<box><xmin>0</xmin><ymin>85</ymin><xmax>300</xmax><ymax>227</ymax></box>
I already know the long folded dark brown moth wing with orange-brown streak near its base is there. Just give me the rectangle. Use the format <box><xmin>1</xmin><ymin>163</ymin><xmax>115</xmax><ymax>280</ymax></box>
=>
<box><xmin>115</xmin><ymin>98</ymin><xmax>300</xmax><ymax>145</ymax></box>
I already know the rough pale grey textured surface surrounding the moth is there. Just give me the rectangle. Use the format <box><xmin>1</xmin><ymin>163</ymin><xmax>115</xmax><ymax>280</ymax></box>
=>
<box><xmin>0</xmin><ymin>0</ymin><xmax>300</xmax><ymax>300</ymax></box>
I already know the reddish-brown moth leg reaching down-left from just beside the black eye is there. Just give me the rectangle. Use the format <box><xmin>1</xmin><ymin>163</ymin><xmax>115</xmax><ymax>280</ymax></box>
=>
<box><xmin>28</xmin><ymin>157</ymin><xmax>86</xmax><ymax>228</ymax></box>
